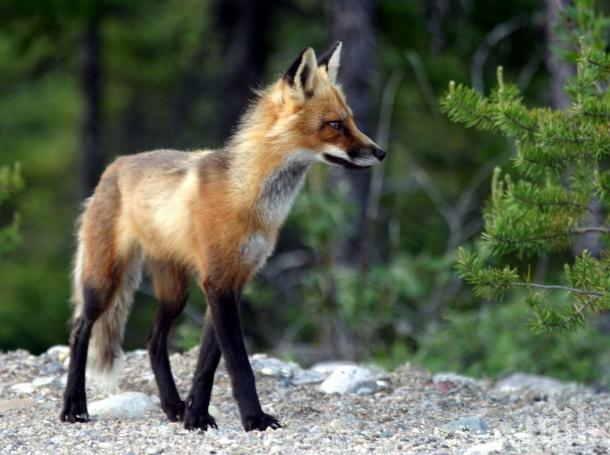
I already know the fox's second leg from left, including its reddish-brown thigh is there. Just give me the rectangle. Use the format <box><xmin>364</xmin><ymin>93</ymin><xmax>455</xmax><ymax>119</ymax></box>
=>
<box><xmin>148</xmin><ymin>262</ymin><xmax>190</xmax><ymax>422</ymax></box>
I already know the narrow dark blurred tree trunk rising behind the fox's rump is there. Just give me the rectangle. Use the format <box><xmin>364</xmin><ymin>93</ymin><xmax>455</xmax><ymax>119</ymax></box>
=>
<box><xmin>81</xmin><ymin>18</ymin><xmax>104</xmax><ymax>196</ymax></box>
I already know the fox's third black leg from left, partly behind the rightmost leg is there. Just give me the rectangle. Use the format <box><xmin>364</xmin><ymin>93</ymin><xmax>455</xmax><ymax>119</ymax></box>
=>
<box><xmin>184</xmin><ymin>307</ymin><xmax>220</xmax><ymax>430</ymax></box>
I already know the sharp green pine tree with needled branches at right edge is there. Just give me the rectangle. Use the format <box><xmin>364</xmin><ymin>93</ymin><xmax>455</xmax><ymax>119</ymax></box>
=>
<box><xmin>441</xmin><ymin>0</ymin><xmax>610</xmax><ymax>331</ymax></box>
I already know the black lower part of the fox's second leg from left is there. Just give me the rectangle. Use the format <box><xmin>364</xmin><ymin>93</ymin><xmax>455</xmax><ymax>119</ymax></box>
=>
<box><xmin>148</xmin><ymin>301</ymin><xmax>186</xmax><ymax>422</ymax></box>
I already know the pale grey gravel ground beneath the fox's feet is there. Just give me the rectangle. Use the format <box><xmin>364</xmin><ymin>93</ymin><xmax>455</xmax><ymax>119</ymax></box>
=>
<box><xmin>0</xmin><ymin>347</ymin><xmax>610</xmax><ymax>455</ymax></box>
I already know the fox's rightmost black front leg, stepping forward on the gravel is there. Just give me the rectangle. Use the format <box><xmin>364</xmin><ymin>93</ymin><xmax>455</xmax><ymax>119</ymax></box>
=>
<box><xmin>205</xmin><ymin>285</ymin><xmax>281</xmax><ymax>431</ymax></box>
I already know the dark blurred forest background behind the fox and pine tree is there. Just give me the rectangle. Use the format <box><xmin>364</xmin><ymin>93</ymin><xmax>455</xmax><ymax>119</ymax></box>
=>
<box><xmin>0</xmin><ymin>0</ymin><xmax>610</xmax><ymax>386</ymax></box>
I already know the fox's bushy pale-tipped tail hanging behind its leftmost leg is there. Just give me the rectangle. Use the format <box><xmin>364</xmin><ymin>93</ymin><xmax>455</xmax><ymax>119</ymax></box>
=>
<box><xmin>71</xmin><ymin>208</ymin><xmax>142</xmax><ymax>391</ymax></box>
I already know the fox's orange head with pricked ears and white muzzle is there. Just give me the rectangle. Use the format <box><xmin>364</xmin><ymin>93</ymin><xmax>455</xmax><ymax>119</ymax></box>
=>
<box><xmin>273</xmin><ymin>42</ymin><xmax>385</xmax><ymax>169</ymax></box>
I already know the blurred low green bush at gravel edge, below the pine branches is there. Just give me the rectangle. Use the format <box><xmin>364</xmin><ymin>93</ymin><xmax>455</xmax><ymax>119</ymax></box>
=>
<box><xmin>415</xmin><ymin>298</ymin><xmax>610</xmax><ymax>387</ymax></box>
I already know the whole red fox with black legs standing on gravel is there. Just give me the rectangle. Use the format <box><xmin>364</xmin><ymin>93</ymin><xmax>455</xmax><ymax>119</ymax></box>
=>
<box><xmin>60</xmin><ymin>42</ymin><xmax>385</xmax><ymax>431</ymax></box>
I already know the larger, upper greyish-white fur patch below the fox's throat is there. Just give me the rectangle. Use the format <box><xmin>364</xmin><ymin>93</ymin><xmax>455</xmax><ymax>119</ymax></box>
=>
<box><xmin>257</xmin><ymin>151</ymin><xmax>312</xmax><ymax>226</ymax></box>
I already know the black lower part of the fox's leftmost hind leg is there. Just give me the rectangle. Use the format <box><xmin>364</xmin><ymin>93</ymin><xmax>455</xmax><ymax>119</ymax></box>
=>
<box><xmin>59</xmin><ymin>287</ymin><xmax>103</xmax><ymax>423</ymax></box>
